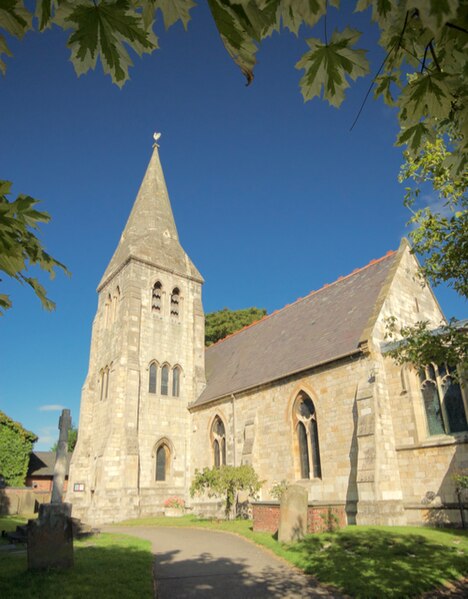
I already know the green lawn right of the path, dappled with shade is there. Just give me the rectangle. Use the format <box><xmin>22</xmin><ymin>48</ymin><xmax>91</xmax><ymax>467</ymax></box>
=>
<box><xmin>123</xmin><ymin>516</ymin><xmax>468</xmax><ymax>599</ymax></box>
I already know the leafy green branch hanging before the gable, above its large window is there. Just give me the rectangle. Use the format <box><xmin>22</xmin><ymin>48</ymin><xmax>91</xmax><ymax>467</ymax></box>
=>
<box><xmin>386</xmin><ymin>317</ymin><xmax>468</xmax><ymax>376</ymax></box>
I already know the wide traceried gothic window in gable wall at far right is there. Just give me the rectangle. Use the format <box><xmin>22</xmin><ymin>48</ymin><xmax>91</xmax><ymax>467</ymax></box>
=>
<box><xmin>419</xmin><ymin>364</ymin><xmax>468</xmax><ymax>435</ymax></box>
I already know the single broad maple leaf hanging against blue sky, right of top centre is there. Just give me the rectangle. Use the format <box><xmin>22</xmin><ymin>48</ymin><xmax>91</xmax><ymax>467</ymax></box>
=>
<box><xmin>296</xmin><ymin>27</ymin><xmax>369</xmax><ymax>107</ymax></box>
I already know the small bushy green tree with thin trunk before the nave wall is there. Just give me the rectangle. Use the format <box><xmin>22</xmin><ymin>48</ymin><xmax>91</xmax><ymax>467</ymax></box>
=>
<box><xmin>190</xmin><ymin>464</ymin><xmax>263</xmax><ymax>518</ymax></box>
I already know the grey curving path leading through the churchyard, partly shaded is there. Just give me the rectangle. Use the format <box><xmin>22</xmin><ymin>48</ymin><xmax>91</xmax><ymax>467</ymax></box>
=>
<box><xmin>103</xmin><ymin>526</ymin><xmax>341</xmax><ymax>599</ymax></box>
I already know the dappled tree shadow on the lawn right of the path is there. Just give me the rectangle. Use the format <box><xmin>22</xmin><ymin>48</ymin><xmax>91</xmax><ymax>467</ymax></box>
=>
<box><xmin>289</xmin><ymin>530</ymin><xmax>468</xmax><ymax>598</ymax></box>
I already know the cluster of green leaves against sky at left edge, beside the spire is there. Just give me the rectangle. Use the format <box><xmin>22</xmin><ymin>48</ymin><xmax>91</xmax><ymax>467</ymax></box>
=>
<box><xmin>0</xmin><ymin>181</ymin><xmax>68</xmax><ymax>315</ymax></box>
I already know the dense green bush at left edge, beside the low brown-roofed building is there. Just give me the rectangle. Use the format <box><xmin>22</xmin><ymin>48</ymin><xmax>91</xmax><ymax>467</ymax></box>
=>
<box><xmin>0</xmin><ymin>412</ymin><xmax>37</xmax><ymax>487</ymax></box>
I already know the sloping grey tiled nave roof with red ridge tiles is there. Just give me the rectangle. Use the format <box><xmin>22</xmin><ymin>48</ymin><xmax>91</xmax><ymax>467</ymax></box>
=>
<box><xmin>194</xmin><ymin>252</ymin><xmax>397</xmax><ymax>406</ymax></box>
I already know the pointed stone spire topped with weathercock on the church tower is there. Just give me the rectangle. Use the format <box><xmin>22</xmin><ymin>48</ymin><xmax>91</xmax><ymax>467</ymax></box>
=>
<box><xmin>98</xmin><ymin>141</ymin><xmax>203</xmax><ymax>291</ymax></box>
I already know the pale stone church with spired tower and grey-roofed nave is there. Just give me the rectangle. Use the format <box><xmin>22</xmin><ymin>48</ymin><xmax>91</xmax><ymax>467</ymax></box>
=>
<box><xmin>66</xmin><ymin>145</ymin><xmax>468</xmax><ymax>524</ymax></box>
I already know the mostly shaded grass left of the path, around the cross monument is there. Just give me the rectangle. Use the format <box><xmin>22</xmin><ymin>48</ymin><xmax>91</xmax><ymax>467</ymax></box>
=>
<box><xmin>0</xmin><ymin>534</ymin><xmax>153</xmax><ymax>599</ymax></box>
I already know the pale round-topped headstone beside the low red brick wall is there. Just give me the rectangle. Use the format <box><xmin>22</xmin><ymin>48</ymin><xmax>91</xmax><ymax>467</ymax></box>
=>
<box><xmin>278</xmin><ymin>485</ymin><xmax>308</xmax><ymax>543</ymax></box>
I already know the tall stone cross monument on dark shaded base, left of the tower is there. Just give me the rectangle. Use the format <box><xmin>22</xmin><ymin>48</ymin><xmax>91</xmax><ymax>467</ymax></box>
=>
<box><xmin>28</xmin><ymin>410</ymin><xmax>73</xmax><ymax>570</ymax></box>
